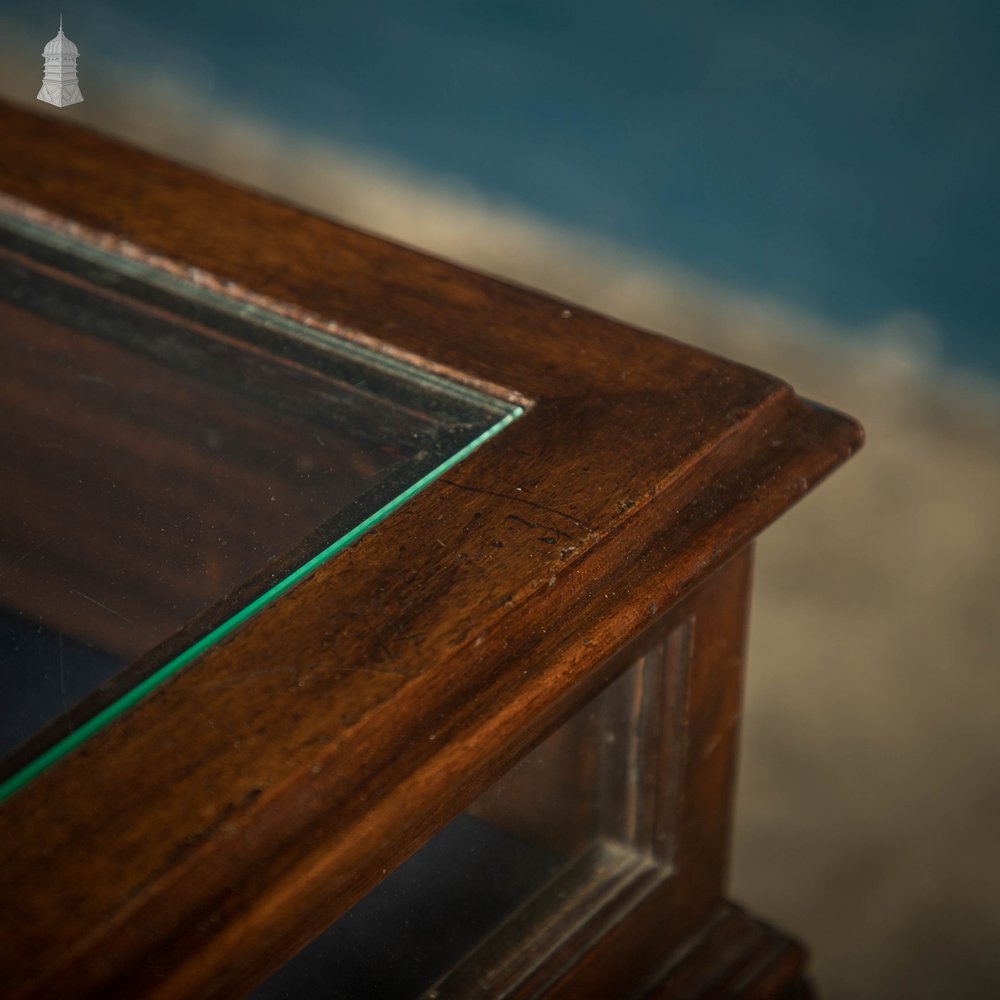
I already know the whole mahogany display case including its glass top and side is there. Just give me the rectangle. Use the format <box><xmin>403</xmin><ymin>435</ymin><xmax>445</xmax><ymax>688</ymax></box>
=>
<box><xmin>0</xmin><ymin>106</ymin><xmax>861</xmax><ymax>1000</ymax></box>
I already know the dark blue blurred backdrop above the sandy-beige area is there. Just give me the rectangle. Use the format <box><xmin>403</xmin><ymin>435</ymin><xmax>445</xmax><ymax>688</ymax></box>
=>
<box><xmin>6</xmin><ymin>0</ymin><xmax>1000</xmax><ymax>377</ymax></box>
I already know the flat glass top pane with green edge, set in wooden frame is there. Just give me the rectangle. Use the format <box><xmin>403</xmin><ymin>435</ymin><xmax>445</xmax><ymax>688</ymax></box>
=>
<box><xmin>0</xmin><ymin>220</ymin><xmax>520</xmax><ymax>794</ymax></box>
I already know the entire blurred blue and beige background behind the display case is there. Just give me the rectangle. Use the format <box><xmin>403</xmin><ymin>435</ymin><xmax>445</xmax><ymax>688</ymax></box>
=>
<box><xmin>0</xmin><ymin>0</ymin><xmax>1000</xmax><ymax>998</ymax></box>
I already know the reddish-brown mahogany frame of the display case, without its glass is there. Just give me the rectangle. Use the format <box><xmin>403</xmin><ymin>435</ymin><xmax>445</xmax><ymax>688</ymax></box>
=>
<box><xmin>0</xmin><ymin>107</ymin><xmax>860</xmax><ymax>998</ymax></box>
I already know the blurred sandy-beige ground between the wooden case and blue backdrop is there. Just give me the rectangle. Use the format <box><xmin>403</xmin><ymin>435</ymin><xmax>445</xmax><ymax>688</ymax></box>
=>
<box><xmin>0</xmin><ymin>55</ymin><xmax>1000</xmax><ymax>1000</ymax></box>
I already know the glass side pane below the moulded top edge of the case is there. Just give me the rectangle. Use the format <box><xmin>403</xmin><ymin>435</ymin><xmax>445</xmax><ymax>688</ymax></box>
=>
<box><xmin>253</xmin><ymin>626</ymin><xmax>689</xmax><ymax>1000</ymax></box>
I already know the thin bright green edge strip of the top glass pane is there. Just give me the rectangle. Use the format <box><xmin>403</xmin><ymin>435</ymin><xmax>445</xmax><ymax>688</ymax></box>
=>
<box><xmin>0</xmin><ymin>406</ymin><xmax>524</xmax><ymax>802</ymax></box>
